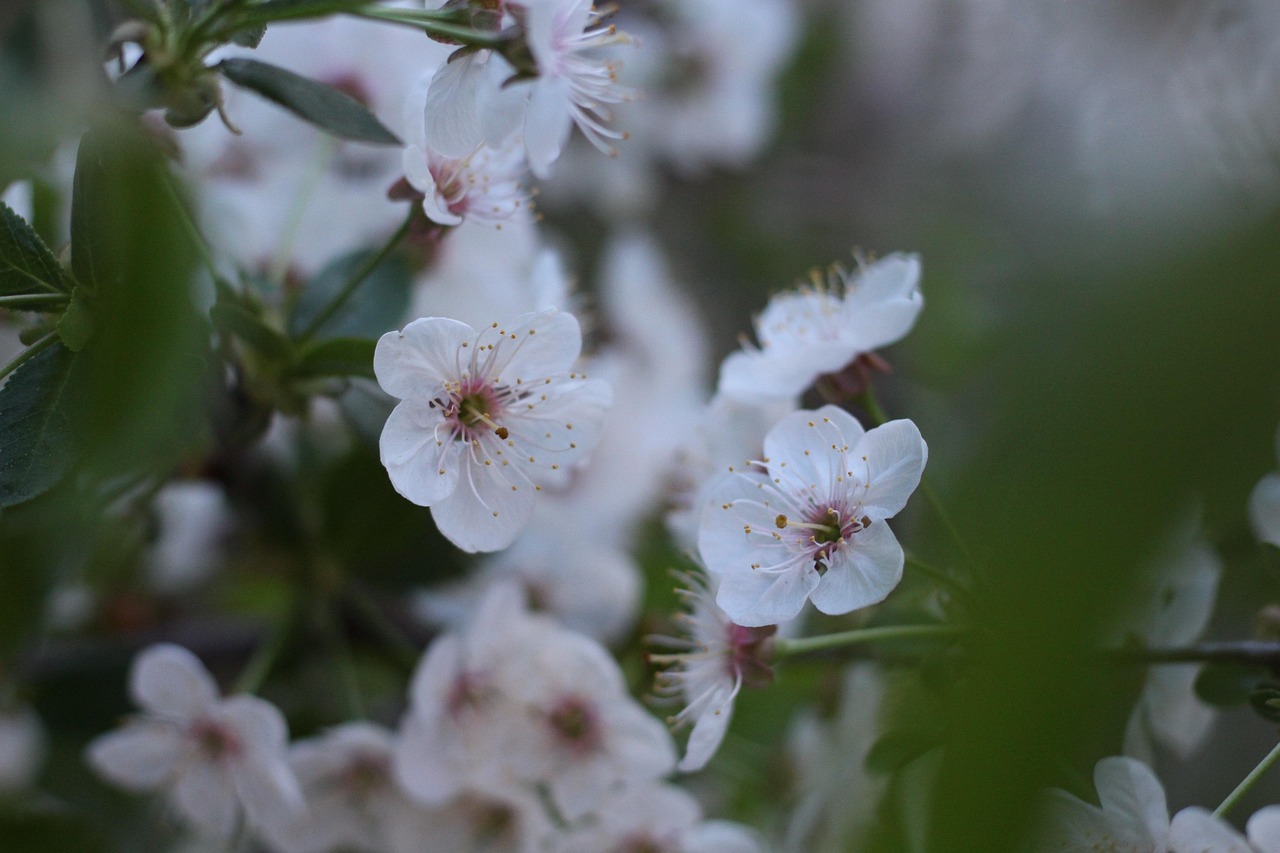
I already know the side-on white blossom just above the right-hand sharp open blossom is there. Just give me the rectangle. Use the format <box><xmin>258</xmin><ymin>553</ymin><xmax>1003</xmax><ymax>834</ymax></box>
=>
<box><xmin>719</xmin><ymin>254</ymin><xmax>924</xmax><ymax>401</ymax></box>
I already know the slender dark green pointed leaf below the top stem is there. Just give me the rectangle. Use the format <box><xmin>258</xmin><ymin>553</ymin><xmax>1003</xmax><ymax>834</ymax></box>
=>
<box><xmin>218</xmin><ymin>58</ymin><xmax>402</xmax><ymax>145</ymax></box>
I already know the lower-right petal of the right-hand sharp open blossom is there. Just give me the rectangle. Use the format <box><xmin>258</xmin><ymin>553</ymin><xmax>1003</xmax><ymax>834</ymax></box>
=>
<box><xmin>810</xmin><ymin>521</ymin><xmax>904</xmax><ymax>616</ymax></box>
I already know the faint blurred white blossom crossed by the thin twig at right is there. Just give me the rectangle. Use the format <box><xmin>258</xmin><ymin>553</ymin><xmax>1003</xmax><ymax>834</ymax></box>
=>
<box><xmin>1117</xmin><ymin>532</ymin><xmax>1222</xmax><ymax>763</ymax></box>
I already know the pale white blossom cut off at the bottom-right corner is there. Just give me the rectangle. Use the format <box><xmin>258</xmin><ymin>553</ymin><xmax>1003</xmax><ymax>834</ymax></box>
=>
<box><xmin>1033</xmin><ymin>757</ymin><xmax>1280</xmax><ymax>853</ymax></box>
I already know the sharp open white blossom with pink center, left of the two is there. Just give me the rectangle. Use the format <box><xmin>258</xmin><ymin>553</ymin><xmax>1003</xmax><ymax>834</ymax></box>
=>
<box><xmin>374</xmin><ymin>309</ymin><xmax>612</xmax><ymax>552</ymax></box>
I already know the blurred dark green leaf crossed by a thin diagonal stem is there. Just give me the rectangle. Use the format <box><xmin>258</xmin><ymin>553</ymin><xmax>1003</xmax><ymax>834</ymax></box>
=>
<box><xmin>289</xmin><ymin>250</ymin><xmax>413</xmax><ymax>338</ymax></box>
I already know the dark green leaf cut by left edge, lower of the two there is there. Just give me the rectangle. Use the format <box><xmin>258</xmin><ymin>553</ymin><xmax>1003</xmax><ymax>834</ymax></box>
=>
<box><xmin>0</xmin><ymin>343</ymin><xmax>77</xmax><ymax>506</ymax></box>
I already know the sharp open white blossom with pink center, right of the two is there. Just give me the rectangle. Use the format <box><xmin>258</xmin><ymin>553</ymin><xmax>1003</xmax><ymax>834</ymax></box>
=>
<box><xmin>698</xmin><ymin>406</ymin><xmax>928</xmax><ymax>626</ymax></box>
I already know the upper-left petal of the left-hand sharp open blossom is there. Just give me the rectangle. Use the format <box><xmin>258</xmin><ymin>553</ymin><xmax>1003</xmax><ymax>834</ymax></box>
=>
<box><xmin>374</xmin><ymin>316</ymin><xmax>476</xmax><ymax>400</ymax></box>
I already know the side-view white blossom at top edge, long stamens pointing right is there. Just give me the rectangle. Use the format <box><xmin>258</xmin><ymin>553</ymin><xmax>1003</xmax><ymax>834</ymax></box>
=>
<box><xmin>509</xmin><ymin>0</ymin><xmax>628</xmax><ymax>178</ymax></box>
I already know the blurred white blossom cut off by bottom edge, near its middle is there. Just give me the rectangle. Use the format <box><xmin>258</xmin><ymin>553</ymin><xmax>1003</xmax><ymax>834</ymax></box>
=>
<box><xmin>556</xmin><ymin>784</ymin><xmax>762</xmax><ymax>853</ymax></box>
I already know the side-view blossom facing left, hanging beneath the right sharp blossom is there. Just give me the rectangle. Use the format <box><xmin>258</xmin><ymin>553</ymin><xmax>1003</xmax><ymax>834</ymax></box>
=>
<box><xmin>649</xmin><ymin>563</ymin><xmax>776</xmax><ymax>772</ymax></box>
